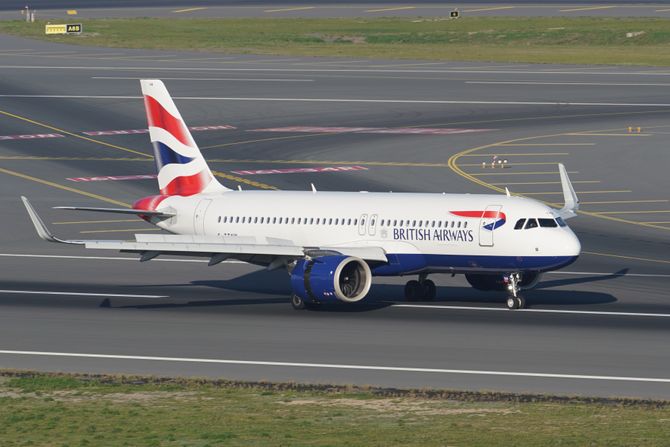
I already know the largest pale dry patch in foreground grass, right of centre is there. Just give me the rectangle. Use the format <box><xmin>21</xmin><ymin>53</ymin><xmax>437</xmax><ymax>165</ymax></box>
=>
<box><xmin>283</xmin><ymin>399</ymin><xmax>519</xmax><ymax>416</ymax></box>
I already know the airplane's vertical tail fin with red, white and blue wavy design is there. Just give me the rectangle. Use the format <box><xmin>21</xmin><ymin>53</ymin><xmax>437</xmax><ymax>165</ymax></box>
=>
<box><xmin>140</xmin><ymin>79</ymin><xmax>228</xmax><ymax>196</ymax></box>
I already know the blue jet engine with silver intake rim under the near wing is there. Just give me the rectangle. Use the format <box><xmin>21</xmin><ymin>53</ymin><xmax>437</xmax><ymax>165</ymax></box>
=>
<box><xmin>291</xmin><ymin>256</ymin><xmax>372</xmax><ymax>303</ymax></box>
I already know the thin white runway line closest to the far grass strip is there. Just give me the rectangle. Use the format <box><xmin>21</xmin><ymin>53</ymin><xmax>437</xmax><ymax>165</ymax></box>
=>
<box><xmin>0</xmin><ymin>65</ymin><xmax>670</xmax><ymax>76</ymax></box>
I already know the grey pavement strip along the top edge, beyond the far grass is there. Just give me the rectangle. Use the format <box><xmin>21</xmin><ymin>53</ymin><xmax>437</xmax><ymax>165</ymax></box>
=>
<box><xmin>0</xmin><ymin>0</ymin><xmax>670</xmax><ymax>20</ymax></box>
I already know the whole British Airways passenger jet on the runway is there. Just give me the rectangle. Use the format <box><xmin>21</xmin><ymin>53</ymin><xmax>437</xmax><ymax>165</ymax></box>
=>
<box><xmin>21</xmin><ymin>80</ymin><xmax>581</xmax><ymax>309</ymax></box>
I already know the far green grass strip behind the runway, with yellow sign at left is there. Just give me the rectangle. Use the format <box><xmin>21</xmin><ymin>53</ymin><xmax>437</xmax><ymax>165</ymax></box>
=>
<box><xmin>0</xmin><ymin>17</ymin><xmax>670</xmax><ymax>66</ymax></box>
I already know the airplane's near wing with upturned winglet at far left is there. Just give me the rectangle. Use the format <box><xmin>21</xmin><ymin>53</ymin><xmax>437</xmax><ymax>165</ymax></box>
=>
<box><xmin>21</xmin><ymin>197</ymin><xmax>388</xmax><ymax>267</ymax></box>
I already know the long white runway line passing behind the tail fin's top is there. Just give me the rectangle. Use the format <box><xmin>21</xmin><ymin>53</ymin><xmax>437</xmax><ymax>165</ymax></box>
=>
<box><xmin>0</xmin><ymin>95</ymin><xmax>670</xmax><ymax>107</ymax></box>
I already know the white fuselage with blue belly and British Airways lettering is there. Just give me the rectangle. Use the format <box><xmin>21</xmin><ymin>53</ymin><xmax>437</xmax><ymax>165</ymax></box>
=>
<box><xmin>152</xmin><ymin>191</ymin><xmax>580</xmax><ymax>275</ymax></box>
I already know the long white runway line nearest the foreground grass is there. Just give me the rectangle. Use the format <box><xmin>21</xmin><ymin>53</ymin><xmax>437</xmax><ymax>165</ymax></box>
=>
<box><xmin>0</xmin><ymin>350</ymin><xmax>670</xmax><ymax>383</ymax></box>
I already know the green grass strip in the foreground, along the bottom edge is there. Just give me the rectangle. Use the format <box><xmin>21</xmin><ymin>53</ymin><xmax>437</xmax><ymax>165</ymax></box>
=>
<box><xmin>0</xmin><ymin>374</ymin><xmax>670</xmax><ymax>447</ymax></box>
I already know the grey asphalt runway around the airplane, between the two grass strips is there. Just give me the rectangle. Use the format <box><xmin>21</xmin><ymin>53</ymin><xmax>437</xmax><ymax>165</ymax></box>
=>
<box><xmin>0</xmin><ymin>37</ymin><xmax>670</xmax><ymax>399</ymax></box>
